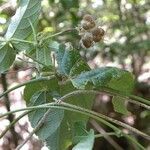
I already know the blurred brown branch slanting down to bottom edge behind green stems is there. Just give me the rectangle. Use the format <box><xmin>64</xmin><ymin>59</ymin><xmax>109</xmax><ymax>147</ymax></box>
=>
<box><xmin>90</xmin><ymin>120</ymin><xmax>123</xmax><ymax>150</ymax></box>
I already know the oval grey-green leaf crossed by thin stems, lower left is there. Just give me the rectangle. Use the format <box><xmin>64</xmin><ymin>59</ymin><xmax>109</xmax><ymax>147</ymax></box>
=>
<box><xmin>29</xmin><ymin>91</ymin><xmax>64</xmax><ymax>140</ymax></box>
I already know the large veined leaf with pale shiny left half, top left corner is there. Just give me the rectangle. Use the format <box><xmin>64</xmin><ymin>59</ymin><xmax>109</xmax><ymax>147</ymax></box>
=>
<box><xmin>5</xmin><ymin>0</ymin><xmax>41</xmax><ymax>39</ymax></box>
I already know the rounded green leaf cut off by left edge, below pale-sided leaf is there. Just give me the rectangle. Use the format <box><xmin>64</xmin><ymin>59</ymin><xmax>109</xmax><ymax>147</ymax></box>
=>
<box><xmin>0</xmin><ymin>43</ymin><xmax>16</xmax><ymax>73</ymax></box>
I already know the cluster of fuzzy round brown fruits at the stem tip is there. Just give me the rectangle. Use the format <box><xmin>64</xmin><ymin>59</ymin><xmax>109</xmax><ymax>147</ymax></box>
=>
<box><xmin>79</xmin><ymin>15</ymin><xmax>105</xmax><ymax>48</ymax></box>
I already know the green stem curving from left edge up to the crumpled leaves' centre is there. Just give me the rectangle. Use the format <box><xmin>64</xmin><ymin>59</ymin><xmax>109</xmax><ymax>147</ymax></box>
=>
<box><xmin>0</xmin><ymin>75</ymin><xmax>55</xmax><ymax>98</ymax></box>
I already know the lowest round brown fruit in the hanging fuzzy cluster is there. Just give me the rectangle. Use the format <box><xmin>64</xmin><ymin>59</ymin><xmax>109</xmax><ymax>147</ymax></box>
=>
<box><xmin>81</xmin><ymin>33</ymin><xmax>93</xmax><ymax>48</ymax></box>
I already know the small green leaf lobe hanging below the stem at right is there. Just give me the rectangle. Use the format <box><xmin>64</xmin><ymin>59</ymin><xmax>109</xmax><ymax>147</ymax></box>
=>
<box><xmin>112</xmin><ymin>96</ymin><xmax>129</xmax><ymax>115</ymax></box>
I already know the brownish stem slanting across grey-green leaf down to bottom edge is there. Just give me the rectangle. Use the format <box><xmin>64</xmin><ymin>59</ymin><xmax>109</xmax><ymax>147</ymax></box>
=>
<box><xmin>16</xmin><ymin>109</ymin><xmax>51</xmax><ymax>150</ymax></box>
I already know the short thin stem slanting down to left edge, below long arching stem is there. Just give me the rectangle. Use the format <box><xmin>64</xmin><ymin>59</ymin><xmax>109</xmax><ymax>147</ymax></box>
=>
<box><xmin>0</xmin><ymin>111</ymin><xmax>31</xmax><ymax>139</ymax></box>
